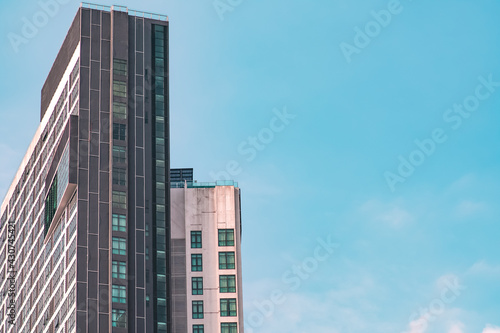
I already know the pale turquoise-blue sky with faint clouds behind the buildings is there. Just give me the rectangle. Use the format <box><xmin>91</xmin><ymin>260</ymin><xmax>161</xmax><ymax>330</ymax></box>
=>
<box><xmin>0</xmin><ymin>0</ymin><xmax>500</xmax><ymax>333</ymax></box>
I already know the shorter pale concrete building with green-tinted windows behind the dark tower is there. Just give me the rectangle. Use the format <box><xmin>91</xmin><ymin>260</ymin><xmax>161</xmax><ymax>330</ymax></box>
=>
<box><xmin>171</xmin><ymin>181</ymin><xmax>243</xmax><ymax>333</ymax></box>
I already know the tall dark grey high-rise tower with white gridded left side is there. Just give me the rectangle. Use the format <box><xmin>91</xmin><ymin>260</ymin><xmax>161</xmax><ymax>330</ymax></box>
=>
<box><xmin>0</xmin><ymin>5</ymin><xmax>172</xmax><ymax>333</ymax></box>
